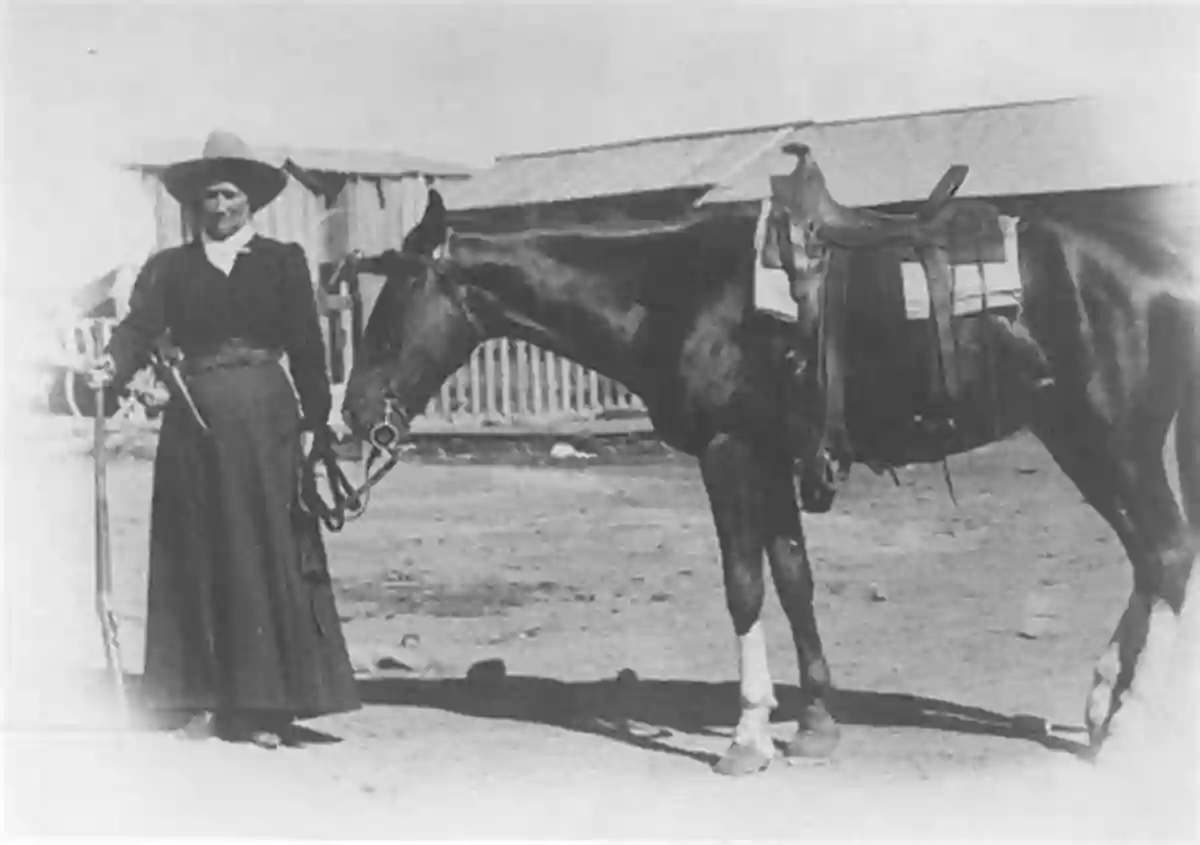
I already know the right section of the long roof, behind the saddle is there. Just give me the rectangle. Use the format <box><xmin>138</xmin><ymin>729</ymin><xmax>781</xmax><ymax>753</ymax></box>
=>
<box><xmin>700</xmin><ymin>98</ymin><xmax>1200</xmax><ymax>205</ymax></box>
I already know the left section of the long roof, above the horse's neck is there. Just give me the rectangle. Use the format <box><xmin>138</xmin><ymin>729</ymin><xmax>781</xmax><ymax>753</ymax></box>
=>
<box><xmin>443</xmin><ymin>121</ymin><xmax>803</xmax><ymax>211</ymax></box>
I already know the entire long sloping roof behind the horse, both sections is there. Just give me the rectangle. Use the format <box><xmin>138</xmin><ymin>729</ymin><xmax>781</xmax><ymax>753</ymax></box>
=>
<box><xmin>443</xmin><ymin>97</ymin><xmax>1200</xmax><ymax>211</ymax></box>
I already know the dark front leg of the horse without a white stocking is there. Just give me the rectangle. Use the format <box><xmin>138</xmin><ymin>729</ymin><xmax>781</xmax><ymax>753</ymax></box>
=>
<box><xmin>763</xmin><ymin>455</ymin><xmax>839</xmax><ymax>757</ymax></box>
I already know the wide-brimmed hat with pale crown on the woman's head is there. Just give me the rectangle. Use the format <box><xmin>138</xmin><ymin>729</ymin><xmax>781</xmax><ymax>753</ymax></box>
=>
<box><xmin>162</xmin><ymin>130</ymin><xmax>288</xmax><ymax>211</ymax></box>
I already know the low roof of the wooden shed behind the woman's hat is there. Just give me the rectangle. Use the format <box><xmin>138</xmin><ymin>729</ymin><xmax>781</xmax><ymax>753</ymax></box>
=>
<box><xmin>127</xmin><ymin>140</ymin><xmax>475</xmax><ymax>179</ymax></box>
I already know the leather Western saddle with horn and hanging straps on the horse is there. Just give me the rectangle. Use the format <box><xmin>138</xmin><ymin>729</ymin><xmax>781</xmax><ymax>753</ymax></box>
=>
<box><xmin>761</xmin><ymin>144</ymin><xmax>1006</xmax><ymax>473</ymax></box>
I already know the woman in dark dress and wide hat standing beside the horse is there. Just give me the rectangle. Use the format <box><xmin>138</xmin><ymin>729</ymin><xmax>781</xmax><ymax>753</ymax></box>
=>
<box><xmin>92</xmin><ymin>132</ymin><xmax>360</xmax><ymax>748</ymax></box>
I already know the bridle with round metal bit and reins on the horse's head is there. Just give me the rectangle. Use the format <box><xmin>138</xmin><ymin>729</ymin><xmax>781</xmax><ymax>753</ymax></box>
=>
<box><xmin>300</xmin><ymin>237</ymin><xmax>487</xmax><ymax>532</ymax></box>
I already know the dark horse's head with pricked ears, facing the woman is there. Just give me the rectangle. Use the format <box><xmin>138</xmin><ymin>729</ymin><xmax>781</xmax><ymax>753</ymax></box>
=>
<box><xmin>342</xmin><ymin>191</ymin><xmax>484</xmax><ymax>451</ymax></box>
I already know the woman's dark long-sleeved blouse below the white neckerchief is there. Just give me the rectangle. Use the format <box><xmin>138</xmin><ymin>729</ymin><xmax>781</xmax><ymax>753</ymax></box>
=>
<box><xmin>108</xmin><ymin>235</ymin><xmax>330</xmax><ymax>429</ymax></box>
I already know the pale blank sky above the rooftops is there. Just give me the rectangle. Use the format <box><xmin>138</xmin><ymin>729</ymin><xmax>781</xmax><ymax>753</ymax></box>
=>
<box><xmin>0</xmin><ymin>0</ymin><xmax>1200</xmax><ymax>307</ymax></box>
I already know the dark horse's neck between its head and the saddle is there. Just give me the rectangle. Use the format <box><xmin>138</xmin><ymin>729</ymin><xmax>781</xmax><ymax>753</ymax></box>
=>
<box><xmin>453</xmin><ymin>218</ymin><xmax>756</xmax><ymax>398</ymax></box>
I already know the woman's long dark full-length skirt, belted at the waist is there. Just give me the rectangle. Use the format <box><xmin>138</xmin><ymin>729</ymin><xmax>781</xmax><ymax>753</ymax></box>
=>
<box><xmin>144</xmin><ymin>361</ymin><xmax>360</xmax><ymax>719</ymax></box>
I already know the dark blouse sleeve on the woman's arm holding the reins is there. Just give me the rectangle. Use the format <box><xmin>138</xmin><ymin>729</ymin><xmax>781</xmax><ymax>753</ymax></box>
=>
<box><xmin>281</xmin><ymin>244</ymin><xmax>332</xmax><ymax>431</ymax></box>
